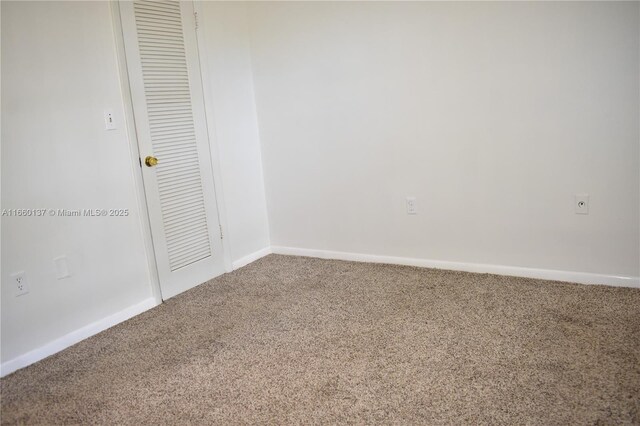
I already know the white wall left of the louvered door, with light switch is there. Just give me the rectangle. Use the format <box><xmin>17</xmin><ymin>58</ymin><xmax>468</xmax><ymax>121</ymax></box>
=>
<box><xmin>1</xmin><ymin>1</ymin><xmax>152</xmax><ymax>366</ymax></box>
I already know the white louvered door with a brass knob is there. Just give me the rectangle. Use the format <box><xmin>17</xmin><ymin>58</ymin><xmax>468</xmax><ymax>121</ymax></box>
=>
<box><xmin>120</xmin><ymin>0</ymin><xmax>224</xmax><ymax>299</ymax></box>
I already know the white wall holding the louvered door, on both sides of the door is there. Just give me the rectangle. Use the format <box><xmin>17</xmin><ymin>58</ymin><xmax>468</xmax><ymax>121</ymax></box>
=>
<box><xmin>1</xmin><ymin>1</ymin><xmax>270</xmax><ymax>374</ymax></box>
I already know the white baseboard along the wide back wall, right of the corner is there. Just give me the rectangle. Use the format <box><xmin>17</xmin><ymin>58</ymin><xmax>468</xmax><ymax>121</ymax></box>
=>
<box><xmin>271</xmin><ymin>246</ymin><xmax>640</xmax><ymax>288</ymax></box>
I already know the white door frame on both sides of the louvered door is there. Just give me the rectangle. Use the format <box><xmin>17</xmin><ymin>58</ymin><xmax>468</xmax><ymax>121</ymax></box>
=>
<box><xmin>109</xmin><ymin>0</ymin><xmax>233</xmax><ymax>304</ymax></box>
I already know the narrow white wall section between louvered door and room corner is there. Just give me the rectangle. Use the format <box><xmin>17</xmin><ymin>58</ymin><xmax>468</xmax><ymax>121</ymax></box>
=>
<box><xmin>199</xmin><ymin>2</ymin><xmax>270</xmax><ymax>264</ymax></box>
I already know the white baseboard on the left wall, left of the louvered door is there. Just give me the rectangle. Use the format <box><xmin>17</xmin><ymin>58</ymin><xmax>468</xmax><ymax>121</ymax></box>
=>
<box><xmin>0</xmin><ymin>297</ymin><xmax>158</xmax><ymax>377</ymax></box>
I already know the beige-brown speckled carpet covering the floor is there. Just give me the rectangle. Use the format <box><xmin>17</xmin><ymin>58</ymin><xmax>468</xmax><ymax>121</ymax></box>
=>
<box><xmin>1</xmin><ymin>255</ymin><xmax>640</xmax><ymax>425</ymax></box>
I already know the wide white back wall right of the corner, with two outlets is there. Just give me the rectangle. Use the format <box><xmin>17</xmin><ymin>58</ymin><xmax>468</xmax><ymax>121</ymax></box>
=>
<box><xmin>250</xmin><ymin>2</ymin><xmax>640</xmax><ymax>277</ymax></box>
